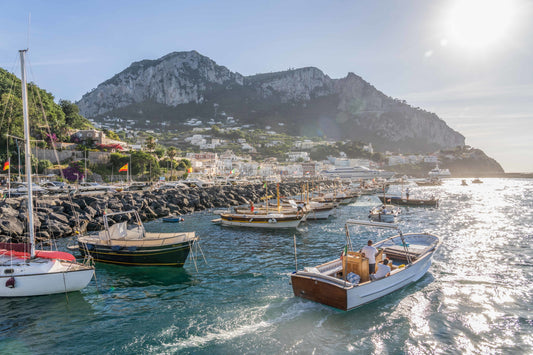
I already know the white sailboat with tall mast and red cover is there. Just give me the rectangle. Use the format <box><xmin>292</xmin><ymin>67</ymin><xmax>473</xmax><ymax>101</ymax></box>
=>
<box><xmin>0</xmin><ymin>49</ymin><xmax>94</xmax><ymax>297</ymax></box>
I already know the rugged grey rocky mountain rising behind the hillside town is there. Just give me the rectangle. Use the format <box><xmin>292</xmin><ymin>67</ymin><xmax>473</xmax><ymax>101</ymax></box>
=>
<box><xmin>77</xmin><ymin>51</ymin><xmax>465</xmax><ymax>153</ymax></box>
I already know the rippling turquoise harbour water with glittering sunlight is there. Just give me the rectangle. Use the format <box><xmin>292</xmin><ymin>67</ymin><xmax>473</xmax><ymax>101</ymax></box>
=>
<box><xmin>0</xmin><ymin>179</ymin><xmax>533</xmax><ymax>354</ymax></box>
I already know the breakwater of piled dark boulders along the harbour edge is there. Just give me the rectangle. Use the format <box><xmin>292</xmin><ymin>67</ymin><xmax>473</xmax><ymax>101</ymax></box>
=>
<box><xmin>0</xmin><ymin>181</ymin><xmax>333</xmax><ymax>242</ymax></box>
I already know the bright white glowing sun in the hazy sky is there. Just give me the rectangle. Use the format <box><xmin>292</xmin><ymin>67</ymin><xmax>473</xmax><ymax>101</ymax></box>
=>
<box><xmin>446</xmin><ymin>0</ymin><xmax>515</xmax><ymax>50</ymax></box>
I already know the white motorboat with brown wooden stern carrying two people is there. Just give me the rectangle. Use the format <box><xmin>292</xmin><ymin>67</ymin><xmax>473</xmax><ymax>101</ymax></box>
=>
<box><xmin>291</xmin><ymin>220</ymin><xmax>439</xmax><ymax>311</ymax></box>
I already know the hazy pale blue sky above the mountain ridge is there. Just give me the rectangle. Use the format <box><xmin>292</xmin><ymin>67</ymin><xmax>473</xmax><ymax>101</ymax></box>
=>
<box><xmin>0</xmin><ymin>0</ymin><xmax>533</xmax><ymax>172</ymax></box>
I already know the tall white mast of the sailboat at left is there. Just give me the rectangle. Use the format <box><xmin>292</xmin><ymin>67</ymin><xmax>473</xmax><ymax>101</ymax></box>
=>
<box><xmin>19</xmin><ymin>49</ymin><xmax>35</xmax><ymax>258</ymax></box>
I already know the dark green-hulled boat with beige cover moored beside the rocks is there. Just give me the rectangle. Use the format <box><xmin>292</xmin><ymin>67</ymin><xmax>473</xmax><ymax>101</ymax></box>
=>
<box><xmin>78</xmin><ymin>210</ymin><xmax>198</xmax><ymax>267</ymax></box>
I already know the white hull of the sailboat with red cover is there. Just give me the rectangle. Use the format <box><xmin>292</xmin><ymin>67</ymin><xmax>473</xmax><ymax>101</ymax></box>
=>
<box><xmin>0</xmin><ymin>260</ymin><xmax>94</xmax><ymax>297</ymax></box>
